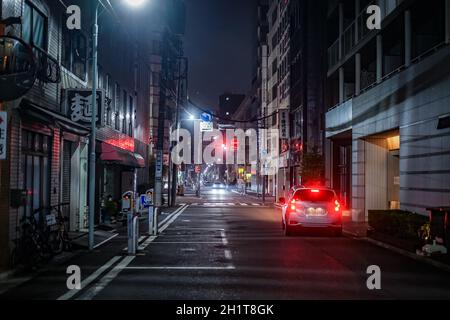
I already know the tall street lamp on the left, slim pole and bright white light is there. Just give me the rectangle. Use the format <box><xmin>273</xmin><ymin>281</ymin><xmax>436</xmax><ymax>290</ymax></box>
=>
<box><xmin>89</xmin><ymin>0</ymin><xmax>146</xmax><ymax>251</ymax></box>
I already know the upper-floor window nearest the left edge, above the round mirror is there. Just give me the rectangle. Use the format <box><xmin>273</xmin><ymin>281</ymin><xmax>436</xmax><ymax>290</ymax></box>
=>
<box><xmin>22</xmin><ymin>1</ymin><xmax>47</xmax><ymax>51</ymax></box>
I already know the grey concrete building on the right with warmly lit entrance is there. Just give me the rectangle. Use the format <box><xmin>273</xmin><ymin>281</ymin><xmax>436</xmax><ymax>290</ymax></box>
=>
<box><xmin>326</xmin><ymin>0</ymin><xmax>450</xmax><ymax>221</ymax></box>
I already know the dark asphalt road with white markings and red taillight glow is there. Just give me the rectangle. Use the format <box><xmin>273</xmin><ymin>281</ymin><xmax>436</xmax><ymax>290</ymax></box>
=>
<box><xmin>0</xmin><ymin>189</ymin><xmax>450</xmax><ymax>300</ymax></box>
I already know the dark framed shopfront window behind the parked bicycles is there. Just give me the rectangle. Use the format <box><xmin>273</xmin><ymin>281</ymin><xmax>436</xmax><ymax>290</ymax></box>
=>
<box><xmin>22</xmin><ymin>130</ymin><xmax>51</xmax><ymax>216</ymax></box>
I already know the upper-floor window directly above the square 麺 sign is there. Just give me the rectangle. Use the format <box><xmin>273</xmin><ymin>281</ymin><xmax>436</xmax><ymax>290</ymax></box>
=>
<box><xmin>61</xmin><ymin>28</ymin><xmax>88</xmax><ymax>80</ymax></box>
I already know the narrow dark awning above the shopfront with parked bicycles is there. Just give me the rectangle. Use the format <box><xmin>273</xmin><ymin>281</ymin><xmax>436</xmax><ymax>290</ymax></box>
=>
<box><xmin>20</xmin><ymin>99</ymin><xmax>90</xmax><ymax>136</ymax></box>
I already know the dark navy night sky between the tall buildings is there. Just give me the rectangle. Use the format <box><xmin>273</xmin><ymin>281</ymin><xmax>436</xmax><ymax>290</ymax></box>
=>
<box><xmin>185</xmin><ymin>0</ymin><xmax>256</xmax><ymax>112</ymax></box>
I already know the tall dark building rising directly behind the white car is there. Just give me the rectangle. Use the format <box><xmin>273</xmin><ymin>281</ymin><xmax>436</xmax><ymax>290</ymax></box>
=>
<box><xmin>288</xmin><ymin>0</ymin><xmax>327</xmax><ymax>187</ymax></box>
